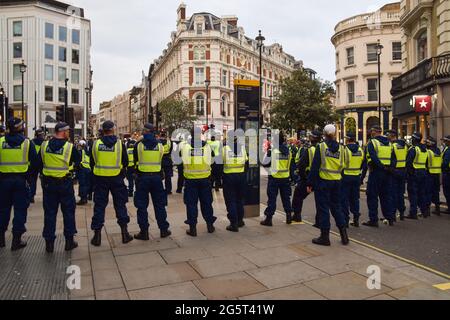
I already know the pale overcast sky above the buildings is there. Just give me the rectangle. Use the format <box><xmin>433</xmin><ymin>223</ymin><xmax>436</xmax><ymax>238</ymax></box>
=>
<box><xmin>66</xmin><ymin>0</ymin><xmax>388</xmax><ymax>111</ymax></box>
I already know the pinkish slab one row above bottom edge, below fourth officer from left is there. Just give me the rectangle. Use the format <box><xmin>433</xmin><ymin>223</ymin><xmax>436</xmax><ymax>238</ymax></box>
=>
<box><xmin>122</xmin><ymin>263</ymin><xmax>200</xmax><ymax>291</ymax></box>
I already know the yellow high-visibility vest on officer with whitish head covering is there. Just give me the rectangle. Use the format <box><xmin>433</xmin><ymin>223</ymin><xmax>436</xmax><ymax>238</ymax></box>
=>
<box><xmin>319</xmin><ymin>142</ymin><xmax>344</xmax><ymax>181</ymax></box>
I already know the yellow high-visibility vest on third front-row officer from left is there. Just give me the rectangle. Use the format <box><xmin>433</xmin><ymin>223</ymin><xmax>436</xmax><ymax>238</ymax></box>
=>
<box><xmin>92</xmin><ymin>140</ymin><xmax>123</xmax><ymax>177</ymax></box>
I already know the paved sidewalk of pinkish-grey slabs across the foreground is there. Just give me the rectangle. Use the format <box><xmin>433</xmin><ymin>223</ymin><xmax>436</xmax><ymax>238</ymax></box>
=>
<box><xmin>0</xmin><ymin>182</ymin><xmax>450</xmax><ymax>300</ymax></box>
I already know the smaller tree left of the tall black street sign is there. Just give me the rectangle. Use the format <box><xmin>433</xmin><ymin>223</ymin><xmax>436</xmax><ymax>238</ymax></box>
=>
<box><xmin>158</xmin><ymin>96</ymin><xmax>197</xmax><ymax>133</ymax></box>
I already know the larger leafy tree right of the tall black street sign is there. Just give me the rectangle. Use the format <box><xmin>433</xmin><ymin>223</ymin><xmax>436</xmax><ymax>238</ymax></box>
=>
<box><xmin>270</xmin><ymin>70</ymin><xmax>338</xmax><ymax>131</ymax></box>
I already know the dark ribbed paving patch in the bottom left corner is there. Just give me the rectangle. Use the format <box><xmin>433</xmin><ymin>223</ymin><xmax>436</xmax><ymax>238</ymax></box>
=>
<box><xmin>0</xmin><ymin>236</ymin><xmax>70</xmax><ymax>300</ymax></box>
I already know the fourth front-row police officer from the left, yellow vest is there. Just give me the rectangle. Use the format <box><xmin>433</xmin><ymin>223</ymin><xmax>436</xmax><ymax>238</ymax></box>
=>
<box><xmin>134</xmin><ymin>123</ymin><xmax>172</xmax><ymax>241</ymax></box>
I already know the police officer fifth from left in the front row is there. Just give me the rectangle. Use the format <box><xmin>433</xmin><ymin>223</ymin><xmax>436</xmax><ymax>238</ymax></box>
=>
<box><xmin>181</xmin><ymin>128</ymin><xmax>217</xmax><ymax>237</ymax></box>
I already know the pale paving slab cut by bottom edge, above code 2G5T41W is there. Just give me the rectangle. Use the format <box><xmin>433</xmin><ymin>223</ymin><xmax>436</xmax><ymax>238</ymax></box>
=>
<box><xmin>240</xmin><ymin>284</ymin><xmax>326</xmax><ymax>300</ymax></box>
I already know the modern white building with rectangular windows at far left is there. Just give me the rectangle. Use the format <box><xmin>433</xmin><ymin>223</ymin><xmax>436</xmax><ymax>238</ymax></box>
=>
<box><xmin>0</xmin><ymin>0</ymin><xmax>92</xmax><ymax>136</ymax></box>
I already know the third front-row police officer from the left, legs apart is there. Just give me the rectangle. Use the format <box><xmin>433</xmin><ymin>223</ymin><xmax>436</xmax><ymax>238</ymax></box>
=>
<box><xmin>91</xmin><ymin>121</ymin><xmax>133</xmax><ymax>247</ymax></box>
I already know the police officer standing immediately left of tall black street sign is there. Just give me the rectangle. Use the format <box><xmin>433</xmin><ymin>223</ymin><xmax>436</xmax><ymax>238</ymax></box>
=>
<box><xmin>222</xmin><ymin>131</ymin><xmax>248</xmax><ymax>232</ymax></box>
